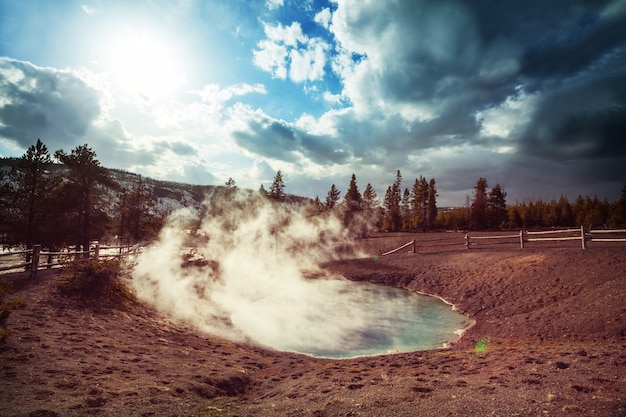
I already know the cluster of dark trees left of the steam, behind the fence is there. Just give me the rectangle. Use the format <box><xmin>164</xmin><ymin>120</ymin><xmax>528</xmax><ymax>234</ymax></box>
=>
<box><xmin>0</xmin><ymin>139</ymin><xmax>164</xmax><ymax>250</ymax></box>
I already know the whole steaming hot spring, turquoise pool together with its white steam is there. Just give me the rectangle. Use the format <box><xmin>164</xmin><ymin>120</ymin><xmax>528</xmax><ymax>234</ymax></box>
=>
<box><xmin>132</xmin><ymin>194</ymin><xmax>471</xmax><ymax>358</ymax></box>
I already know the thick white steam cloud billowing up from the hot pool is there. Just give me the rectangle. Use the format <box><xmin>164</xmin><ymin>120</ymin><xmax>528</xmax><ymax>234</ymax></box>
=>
<box><xmin>133</xmin><ymin>192</ymin><xmax>371</xmax><ymax>352</ymax></box>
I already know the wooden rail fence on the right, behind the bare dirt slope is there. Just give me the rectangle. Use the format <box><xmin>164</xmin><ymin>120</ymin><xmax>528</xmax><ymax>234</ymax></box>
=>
<box><xmin>382</xmin><ymin>226</ymin><xmax>626</xmax><ymax>256</ymax></box>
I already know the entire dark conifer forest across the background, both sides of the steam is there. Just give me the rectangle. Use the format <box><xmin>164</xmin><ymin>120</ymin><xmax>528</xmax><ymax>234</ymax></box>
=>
<box><xmin>0</xmin><ymin>139</ymin><xmax>626</xmax><ymax>248</ymax></box>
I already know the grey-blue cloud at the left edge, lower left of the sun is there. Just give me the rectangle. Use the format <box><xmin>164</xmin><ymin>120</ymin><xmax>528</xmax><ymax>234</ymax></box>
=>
<box><xmin>0</xmin><ymin>58</ymin><xmax>100</xmax><ymax>148</ymax></box>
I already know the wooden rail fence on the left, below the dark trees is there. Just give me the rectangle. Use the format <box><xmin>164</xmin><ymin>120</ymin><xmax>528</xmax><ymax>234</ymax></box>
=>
<box><xmin>0</xmin><ymin>243</ymin><xmax>138</xmax><ymax>278</ymax></box>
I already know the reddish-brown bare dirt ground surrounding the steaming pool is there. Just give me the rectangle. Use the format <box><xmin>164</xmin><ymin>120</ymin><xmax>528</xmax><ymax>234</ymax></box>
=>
<box><xmin>0</xmin><ymin>234</ymin><xmax>626</xmax><ymax>417</ymax></box>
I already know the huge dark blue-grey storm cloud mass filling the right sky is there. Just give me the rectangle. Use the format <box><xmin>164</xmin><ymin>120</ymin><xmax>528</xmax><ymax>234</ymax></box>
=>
<box><xmin>326</xmin><ymin>0</ymin><xmax>626</xmax><ymax>199</ymax></box>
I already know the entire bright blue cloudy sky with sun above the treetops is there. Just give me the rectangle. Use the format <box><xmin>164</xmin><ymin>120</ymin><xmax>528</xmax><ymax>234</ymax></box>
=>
<box><xmin>0</xmin><ymin>0</ymin><xmax>626</xmax><ymax>207</ymax></box>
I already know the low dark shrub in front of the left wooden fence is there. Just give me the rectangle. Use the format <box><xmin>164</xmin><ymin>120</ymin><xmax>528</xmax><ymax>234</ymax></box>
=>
<box><xmin>59</xmin><ymin>259</ymin><xmax>134</xmax><ymax>305</ymax></box>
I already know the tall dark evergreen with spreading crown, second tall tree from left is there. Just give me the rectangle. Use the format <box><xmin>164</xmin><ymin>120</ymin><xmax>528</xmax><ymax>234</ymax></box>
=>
<box><xmin>54</xmin><ymin>144</ymin><xmax>117</xmax><ymax>256</ymax></box>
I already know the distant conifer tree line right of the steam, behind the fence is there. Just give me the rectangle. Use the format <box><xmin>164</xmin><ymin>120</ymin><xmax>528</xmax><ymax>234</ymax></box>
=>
<box><xmin>260</xmin><ymin>170</ymin><xmax>626</xmax><ymax>233</ymax></box>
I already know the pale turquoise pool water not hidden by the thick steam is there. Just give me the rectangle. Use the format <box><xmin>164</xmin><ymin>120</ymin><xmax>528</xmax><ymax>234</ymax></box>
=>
<box><xmin>279</xmin><ymin>282</ymin><xmax>473</xmax><ymax>358</ymax></box>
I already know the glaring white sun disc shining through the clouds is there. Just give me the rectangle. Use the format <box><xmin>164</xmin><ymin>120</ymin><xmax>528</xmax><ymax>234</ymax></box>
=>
<box><xmin>106</xmin><ymin>34</ymin><xmax>185</xmax><ymax>97</ymax></box>
